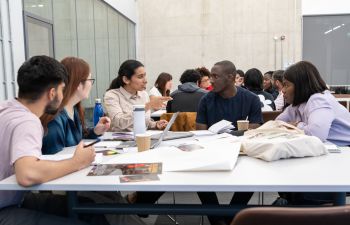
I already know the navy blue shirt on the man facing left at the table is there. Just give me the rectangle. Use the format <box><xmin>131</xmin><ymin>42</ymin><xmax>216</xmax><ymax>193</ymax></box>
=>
<box><xmin>196</xmin><ymin>87</ymin><xmax>263</xmax><ymax>127</ymax></box>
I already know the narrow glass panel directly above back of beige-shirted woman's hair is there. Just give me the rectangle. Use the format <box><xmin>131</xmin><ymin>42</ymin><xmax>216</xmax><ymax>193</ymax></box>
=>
<box><xmin>108</xmin><ymin>8</ymin><xmax>120</xmax><ymax>82</ymax></box>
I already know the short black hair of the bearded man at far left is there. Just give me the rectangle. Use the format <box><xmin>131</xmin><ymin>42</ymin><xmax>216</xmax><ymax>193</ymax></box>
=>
<box><xmin>17</xmin><ymin>55</ymin><xmax>68</xmax><ymax>101</ymax></box>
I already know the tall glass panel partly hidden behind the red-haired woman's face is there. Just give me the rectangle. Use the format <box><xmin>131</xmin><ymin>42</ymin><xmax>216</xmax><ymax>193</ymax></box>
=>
<box><xmin>76</xmin><ymin>0</ymin><xmax>97</xmax><ymax>107</ymax></box>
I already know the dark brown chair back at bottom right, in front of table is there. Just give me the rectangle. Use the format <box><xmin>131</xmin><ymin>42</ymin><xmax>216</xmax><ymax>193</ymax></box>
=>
<box><xmin>231</xmin><ymin>205</ymin><xmax>350</xmax><ymax>225</ymax></box>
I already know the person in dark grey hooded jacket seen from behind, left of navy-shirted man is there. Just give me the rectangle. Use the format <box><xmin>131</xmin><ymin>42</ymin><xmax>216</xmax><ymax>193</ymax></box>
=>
<box><xmin>166</xmin><ymin>70</ymin><xmax>208</xmax><ymax>113</ymax></box>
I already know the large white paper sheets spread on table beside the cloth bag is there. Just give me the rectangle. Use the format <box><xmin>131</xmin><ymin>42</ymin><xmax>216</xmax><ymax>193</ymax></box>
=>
<box><xmin>105</xmin><ymin>139</ymin><xmax>240</xmax><ymax>171</ymax></box>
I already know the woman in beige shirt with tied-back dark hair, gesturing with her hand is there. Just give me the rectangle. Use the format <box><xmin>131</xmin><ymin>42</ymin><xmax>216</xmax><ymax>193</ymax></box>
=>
<box><xmin>104</xmin><ymin>60</ymin><xmax>171</xmax><ymax>131</ymax></box>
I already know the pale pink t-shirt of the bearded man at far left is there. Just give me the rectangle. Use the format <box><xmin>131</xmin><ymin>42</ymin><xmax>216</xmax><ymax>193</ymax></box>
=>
<box><xmin>0</xmin><ymin>99</ymin><xmax>44</xmax><ymax>208</ymax></box>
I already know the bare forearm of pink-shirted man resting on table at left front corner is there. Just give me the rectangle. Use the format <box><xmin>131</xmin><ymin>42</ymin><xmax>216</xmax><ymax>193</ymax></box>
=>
<box><xmin>15</xmin><ymin>157</ymin><xmax>82</xmax><ymax>186</ymax></box>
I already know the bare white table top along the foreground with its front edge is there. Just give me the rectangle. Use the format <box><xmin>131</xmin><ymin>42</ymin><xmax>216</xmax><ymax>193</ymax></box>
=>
<box><xmin>0</xmin><ymin>136</ymin><xmax>350</xmax><ymax>192</ymax></box>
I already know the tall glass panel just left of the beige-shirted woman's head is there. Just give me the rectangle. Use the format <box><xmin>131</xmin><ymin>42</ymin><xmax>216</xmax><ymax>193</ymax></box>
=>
<box><xmin>94</xmin><ymin>0</ymin><xmax>109</xmax><ymax>98</ymax></box>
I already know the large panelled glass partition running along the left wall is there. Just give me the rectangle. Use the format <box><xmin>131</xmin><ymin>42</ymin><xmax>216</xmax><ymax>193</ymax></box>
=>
<box><xmin>23</xmin><ymin>0</ymin><xmax>136</xmax><ymax>107</ymax></box>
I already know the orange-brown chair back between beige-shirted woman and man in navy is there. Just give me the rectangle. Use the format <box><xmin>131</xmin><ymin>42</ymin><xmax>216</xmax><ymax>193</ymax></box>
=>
<box><xmin>160</xmin><ymin>112</ymin><xmax>197</xmax><ymax>131</ymax></box>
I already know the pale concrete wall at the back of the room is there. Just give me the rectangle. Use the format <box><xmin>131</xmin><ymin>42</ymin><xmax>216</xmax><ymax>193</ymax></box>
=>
<box><xmin>137</xmin><ymin>0</ymin><xmax>301</xmax><ymax>87</ymax></box>
